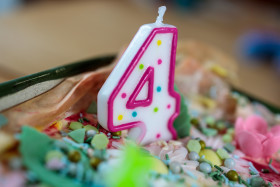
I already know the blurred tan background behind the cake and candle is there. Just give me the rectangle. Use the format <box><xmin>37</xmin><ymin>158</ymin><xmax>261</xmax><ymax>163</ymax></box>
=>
<box><xmin>0</xmin><ymin>0</ymin><xmax>280</xmax><ymax>107</ymax></box>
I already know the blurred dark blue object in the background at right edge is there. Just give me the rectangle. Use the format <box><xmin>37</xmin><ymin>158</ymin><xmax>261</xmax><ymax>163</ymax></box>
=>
<box><xmin>240</xmin><ymin>31</ymin><xmax>280</xmax><ymax>71</ymax></box>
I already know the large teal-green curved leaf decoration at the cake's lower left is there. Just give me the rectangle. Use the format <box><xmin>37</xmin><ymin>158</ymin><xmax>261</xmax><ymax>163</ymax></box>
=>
<box><xmin>20</xmin><ymin>126</ymin><xmax>90</xmax><ymax>187</ymax></box>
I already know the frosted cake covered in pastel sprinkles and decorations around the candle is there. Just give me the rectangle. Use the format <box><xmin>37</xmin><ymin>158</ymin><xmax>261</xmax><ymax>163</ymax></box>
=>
<box><xmin>0</xmin><ymin>41</ymin><xmax>280</xmax><ymax>187</ymax></box>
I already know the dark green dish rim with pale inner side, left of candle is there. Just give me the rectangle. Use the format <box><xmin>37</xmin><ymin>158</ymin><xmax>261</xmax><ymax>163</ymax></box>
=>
<box><xmin>0</xmin><ymin>55</ymin><xmax>116</xmax><ymax>112</ymax></box>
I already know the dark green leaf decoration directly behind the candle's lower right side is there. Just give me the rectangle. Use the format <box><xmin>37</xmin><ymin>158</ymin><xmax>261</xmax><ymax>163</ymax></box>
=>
<box><xmin>173</xmin><ymin>85</ymin><xmax>191</xmax><ymax>138</ymax></box>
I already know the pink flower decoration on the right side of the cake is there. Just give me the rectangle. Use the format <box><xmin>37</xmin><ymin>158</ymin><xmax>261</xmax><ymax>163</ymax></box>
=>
<box><xmin>235</xmin><ymin>115</ymin><xmax>280</xmax><ymax>158</ymax></box>
